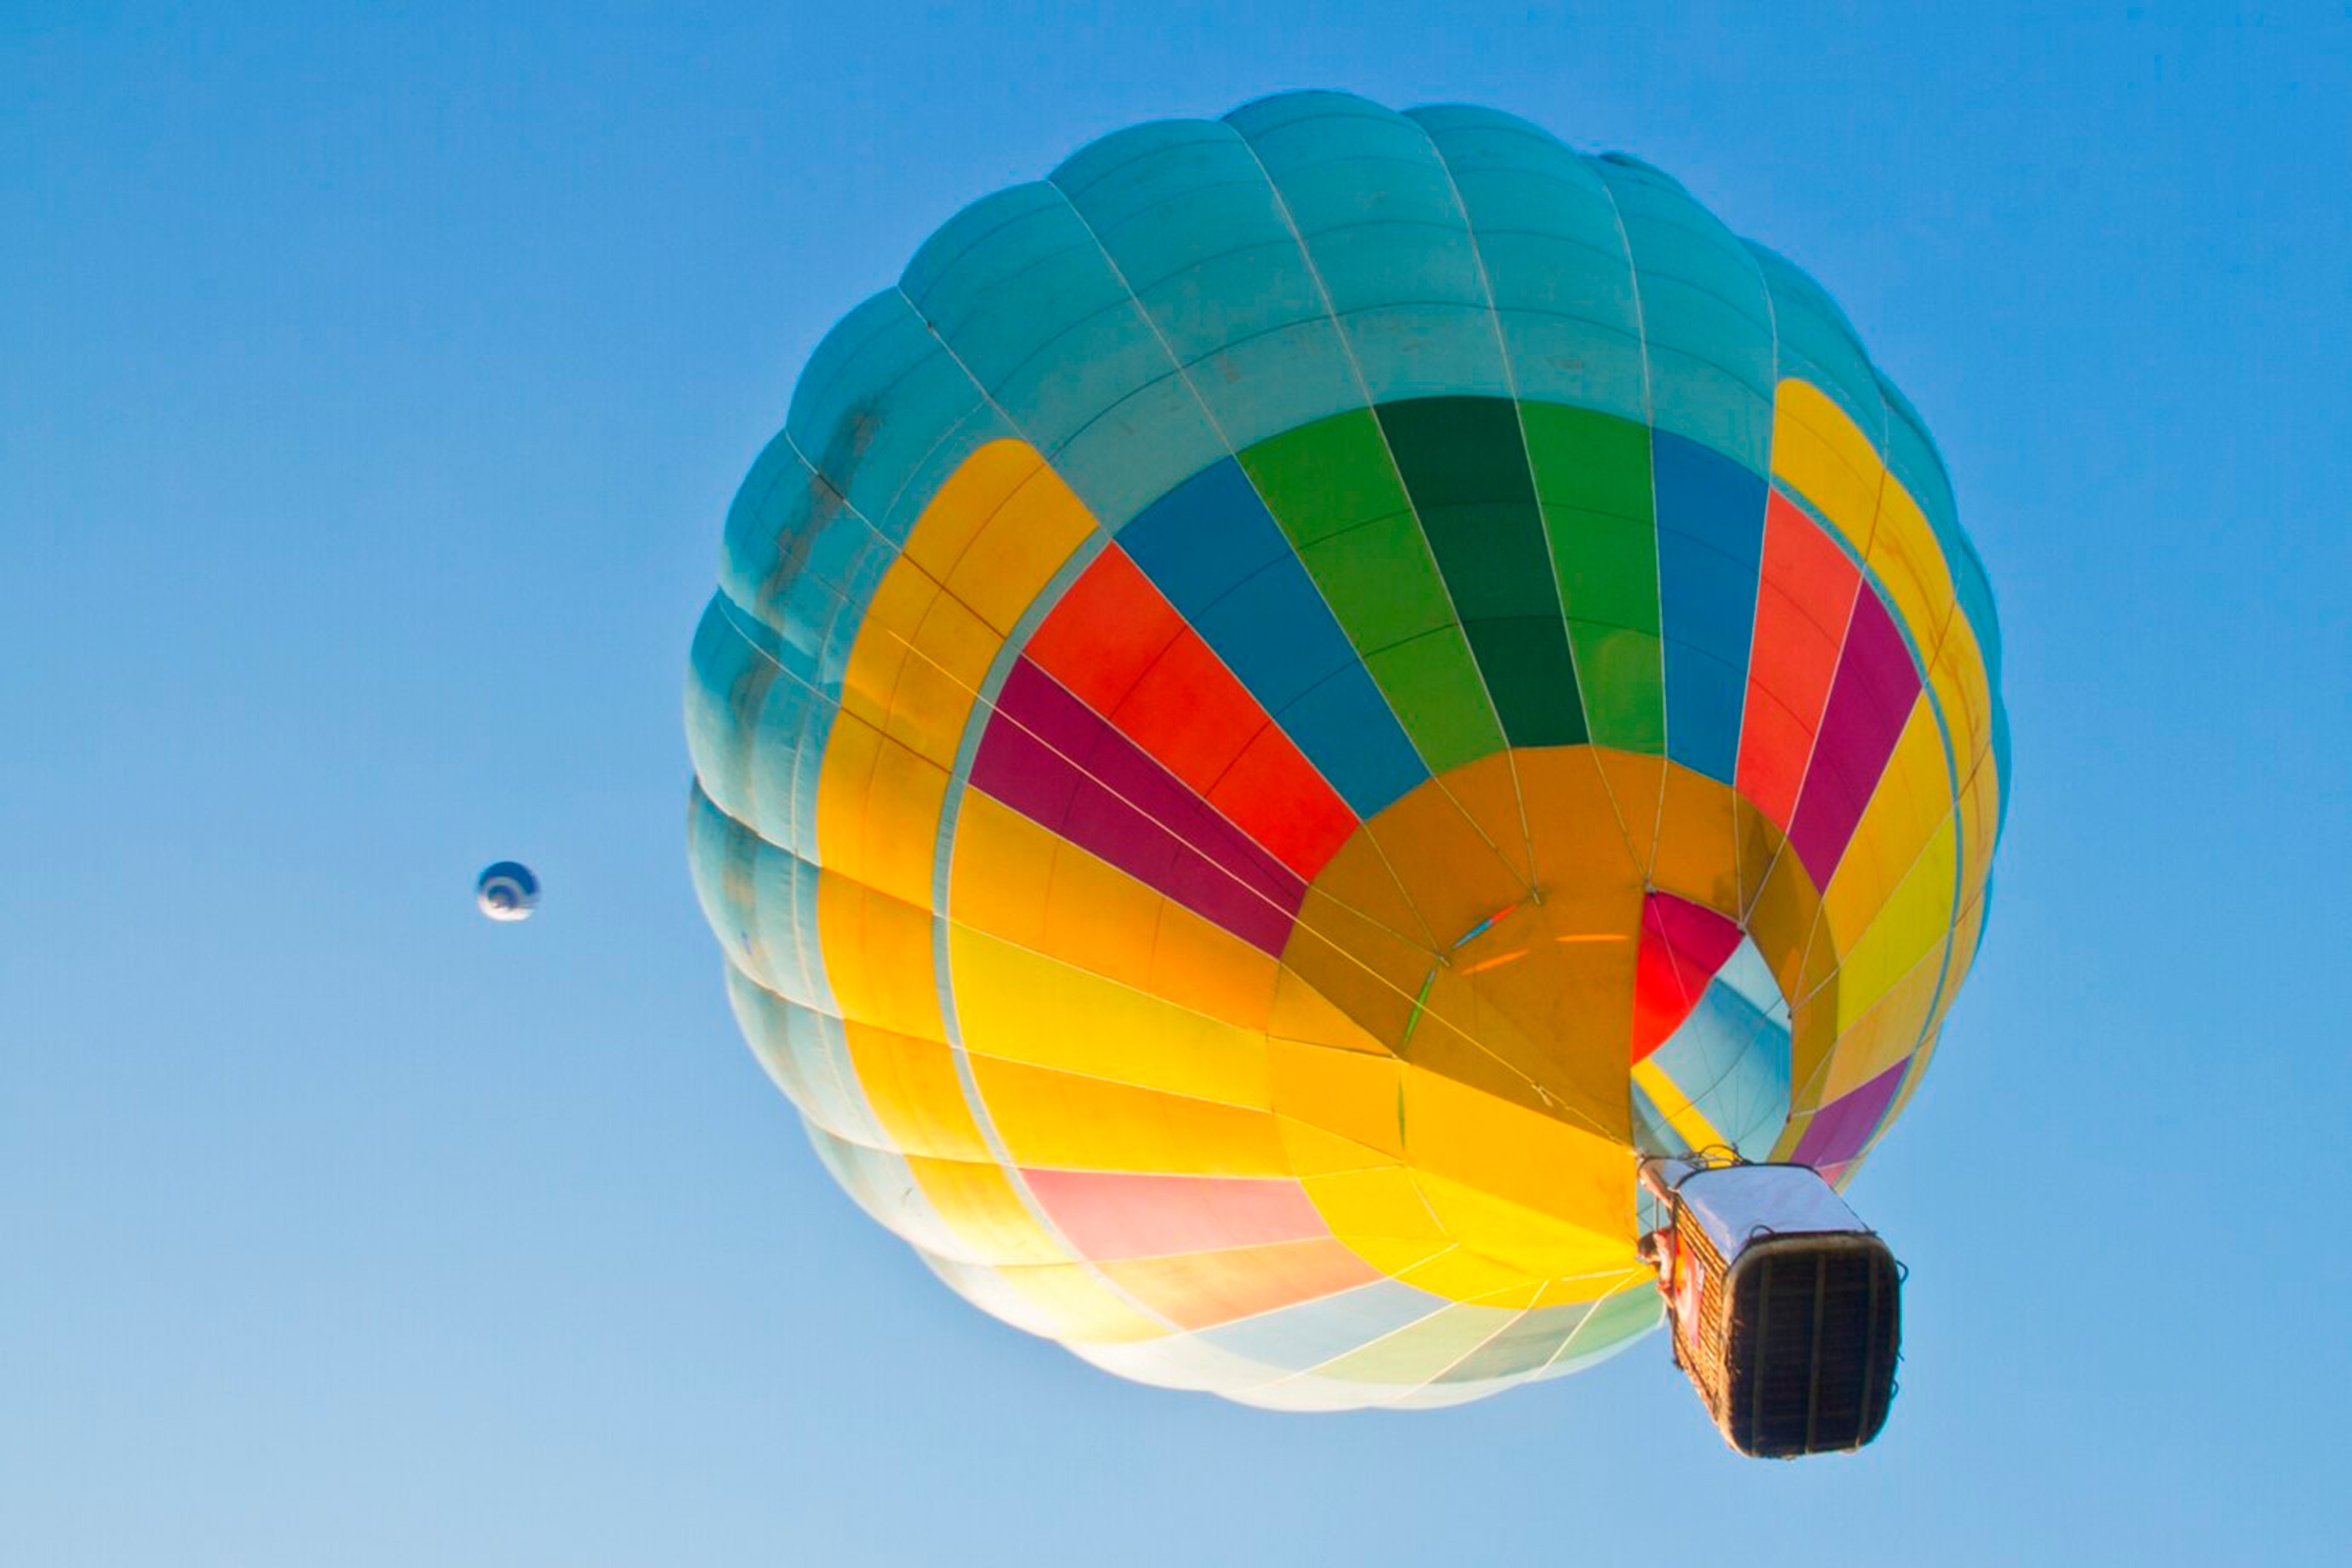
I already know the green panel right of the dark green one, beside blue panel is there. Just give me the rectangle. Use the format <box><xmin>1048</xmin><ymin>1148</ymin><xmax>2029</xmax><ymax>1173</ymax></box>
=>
<box><xmin>1519</xmin><ymin>402</ymin><xmax>1665</xmax><ymax>753</ymax></box>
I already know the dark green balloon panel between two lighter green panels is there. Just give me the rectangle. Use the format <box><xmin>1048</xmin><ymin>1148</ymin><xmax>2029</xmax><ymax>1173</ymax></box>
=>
<box><xmin>1378</xmin><ymin>397</ymin><xmax>1586</xmax><ymax>745</ymax></box>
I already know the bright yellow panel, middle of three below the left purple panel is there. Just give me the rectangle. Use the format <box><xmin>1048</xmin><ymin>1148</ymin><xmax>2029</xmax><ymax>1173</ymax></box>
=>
<box><xmin>948</xmin><ymin>926</ymin><xmax>1270</xmax><ymax>1109</ymax></box>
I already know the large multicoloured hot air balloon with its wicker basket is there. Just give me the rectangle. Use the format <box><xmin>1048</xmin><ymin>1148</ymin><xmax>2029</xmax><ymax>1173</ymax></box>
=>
<box><xmin>687</xmin><ymin>92</ymin><xmax>2009</xmax><ymax>1452</ymax></box>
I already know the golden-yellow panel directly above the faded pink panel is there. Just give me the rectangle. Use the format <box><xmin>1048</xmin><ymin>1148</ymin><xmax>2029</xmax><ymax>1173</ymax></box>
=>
<box><xmin>971</xmin><ymin>1055</ymin><xmax>1292</xmax><ymax>1175</ymax></box>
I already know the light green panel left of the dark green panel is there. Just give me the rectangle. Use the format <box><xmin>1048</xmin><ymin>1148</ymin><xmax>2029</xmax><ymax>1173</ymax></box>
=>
<box><xmin>1242</xmin><ymin>409</ymin><xmax>1503</xmax><ymax>773</ymax></box>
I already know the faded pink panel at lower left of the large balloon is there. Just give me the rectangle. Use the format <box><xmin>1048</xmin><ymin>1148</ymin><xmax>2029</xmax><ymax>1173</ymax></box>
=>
<box><xmin>1021</xmin><ymin>1171</ymin><xmax>1331</xmax><ymax>1260</ymax></box>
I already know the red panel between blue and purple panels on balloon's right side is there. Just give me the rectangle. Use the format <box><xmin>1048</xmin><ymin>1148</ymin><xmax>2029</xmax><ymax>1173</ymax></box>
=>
<box><xmin>1739</xmin><ymin>491</ymin><xmax>1863</xmax><ymax>830</ymax></box>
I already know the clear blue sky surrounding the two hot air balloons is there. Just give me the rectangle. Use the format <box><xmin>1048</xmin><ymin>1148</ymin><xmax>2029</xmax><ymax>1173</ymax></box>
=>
<box><xmin>0</xmin><ymin>0</ymin><xmax>2352</xmax><ymax>1568</ymax></box>
